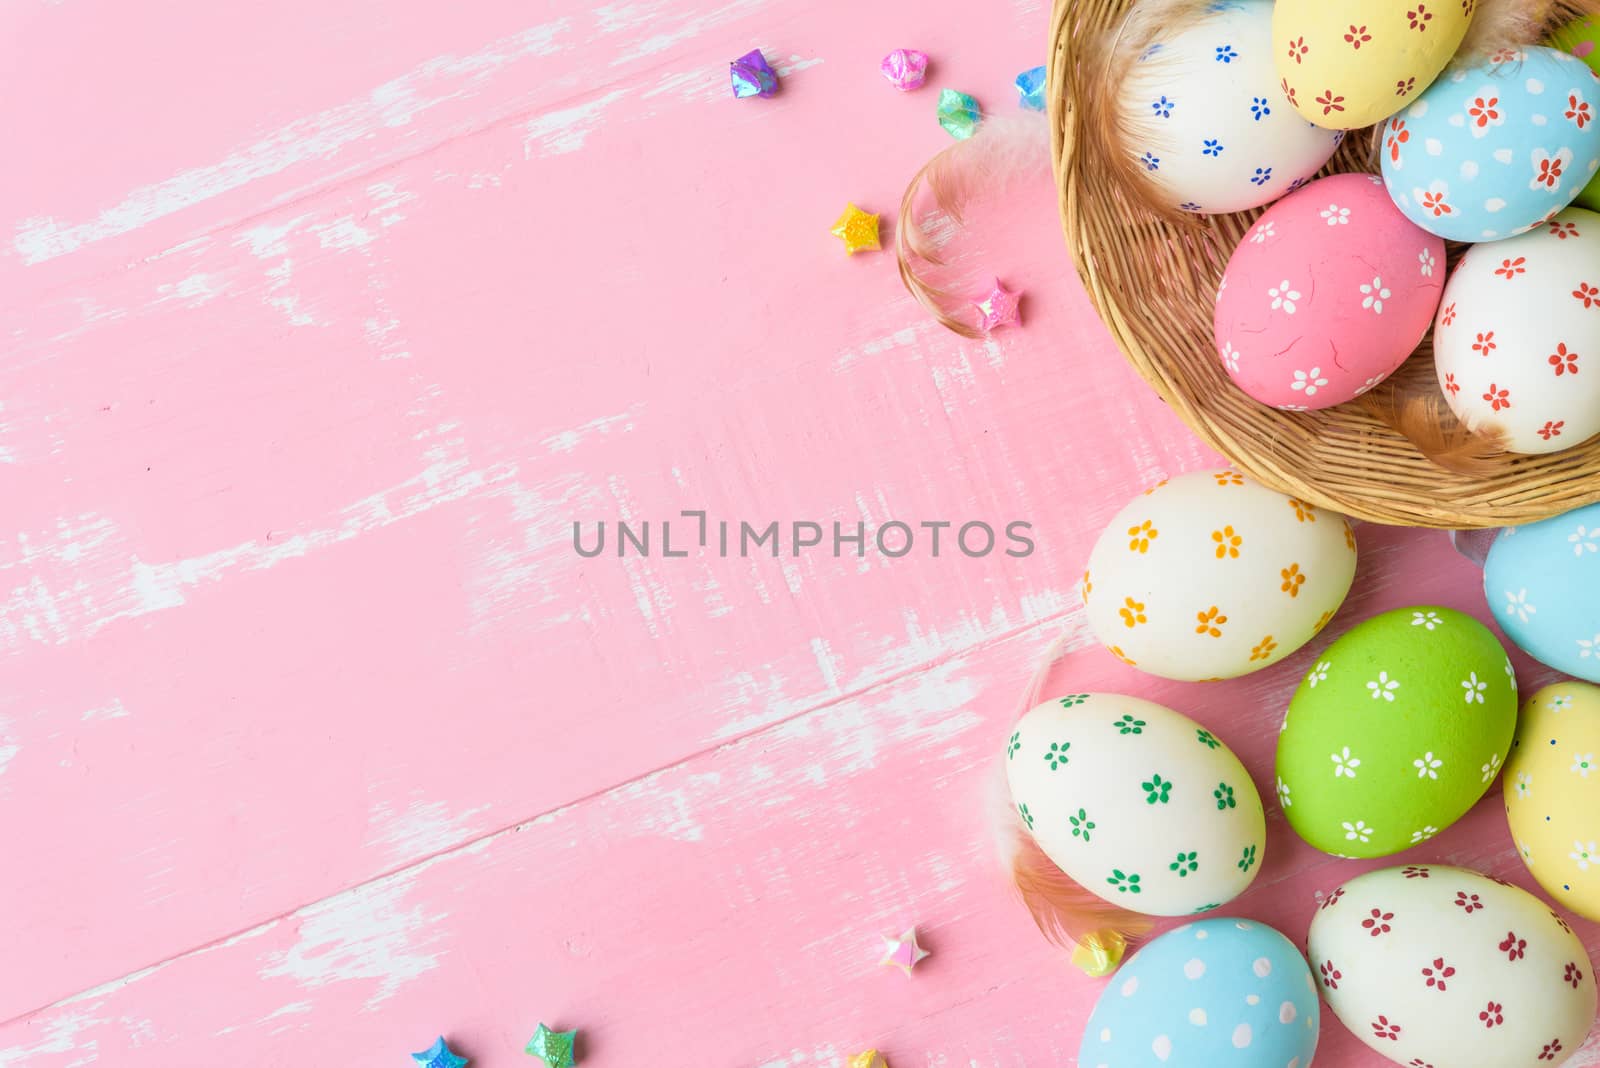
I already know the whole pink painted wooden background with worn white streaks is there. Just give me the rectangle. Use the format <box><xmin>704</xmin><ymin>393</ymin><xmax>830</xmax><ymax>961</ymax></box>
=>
<box><xmin>0</xmin><ymin>0</ymin><xmax>1600</xmax><ymax>1068</ymax></box>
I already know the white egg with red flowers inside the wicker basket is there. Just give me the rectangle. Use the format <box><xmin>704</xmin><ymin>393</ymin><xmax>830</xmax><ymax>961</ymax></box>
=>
<box><xmin>1434</xmin><ymin>208</ymin><xmax>1600</xmax><ymax>452</ymax></box>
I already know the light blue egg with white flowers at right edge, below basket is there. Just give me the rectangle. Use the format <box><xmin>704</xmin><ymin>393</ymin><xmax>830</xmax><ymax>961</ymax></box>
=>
<box><xmin>1483</xmin><ymin>504</ymin><xmax>1600</xmax><ymax>683</ymax></box>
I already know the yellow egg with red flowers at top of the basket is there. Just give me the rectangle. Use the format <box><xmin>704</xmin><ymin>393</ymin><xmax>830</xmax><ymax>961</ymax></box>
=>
<box><xmin>1272</xmin><ymin>0</ymin><xmax>1472</xmax><ymax>130</ymax></box>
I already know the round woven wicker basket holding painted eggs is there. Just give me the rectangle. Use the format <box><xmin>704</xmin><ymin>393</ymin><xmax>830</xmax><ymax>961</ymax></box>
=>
<box><xmin>1048</xmin><ymin>0</ymin><xmax>1600</xmax><ymax>528</ymax></box>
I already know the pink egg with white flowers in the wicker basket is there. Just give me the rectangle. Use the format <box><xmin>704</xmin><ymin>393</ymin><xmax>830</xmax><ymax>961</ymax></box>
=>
<box><xmin>1213</xmin><ymin>174</ymin><xmax>1445</xmax><ymax>411</ymax></box>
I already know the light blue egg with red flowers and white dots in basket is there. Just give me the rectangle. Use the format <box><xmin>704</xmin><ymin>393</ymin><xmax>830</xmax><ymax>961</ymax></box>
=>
<box><xmin>1381</xmin><ymin>48</ymin><xmax>1600</xmax><ymax>241</ymax></box>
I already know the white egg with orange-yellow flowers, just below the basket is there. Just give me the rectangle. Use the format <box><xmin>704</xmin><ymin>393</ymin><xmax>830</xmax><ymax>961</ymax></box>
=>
<box><xmin>1083</xmin><ymin>470</ymin><xmax>1355</xmax><ymax>681</ymax></box>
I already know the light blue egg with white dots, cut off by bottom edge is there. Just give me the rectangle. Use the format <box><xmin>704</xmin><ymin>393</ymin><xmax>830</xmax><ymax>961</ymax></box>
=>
<box><xmin>1078</xmin><ymin>919</ymin><xmax>1322</xmax><ymax>1068</ymax></box>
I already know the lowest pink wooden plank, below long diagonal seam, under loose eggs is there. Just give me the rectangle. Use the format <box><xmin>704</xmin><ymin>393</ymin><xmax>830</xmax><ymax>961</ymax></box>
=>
<box><xmin>0</xmin><ymin>528</ymin><xmax>1580</xmax><ymax>1068</ymax></box>
